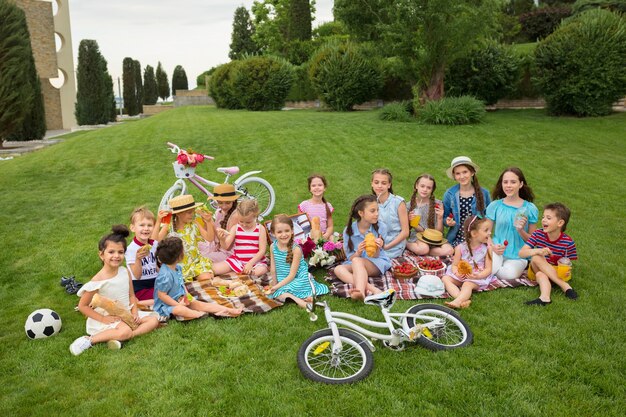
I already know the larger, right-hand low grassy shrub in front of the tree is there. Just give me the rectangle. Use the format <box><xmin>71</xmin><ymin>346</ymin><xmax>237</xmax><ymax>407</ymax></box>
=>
<box><xmin>413</xmin><ymin>96</ymin><xmax>485</xmax><ymax>125</ymax></box>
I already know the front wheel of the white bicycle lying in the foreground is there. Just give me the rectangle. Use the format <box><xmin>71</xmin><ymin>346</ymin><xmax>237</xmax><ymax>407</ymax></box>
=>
<box><xmin>298</xmin><ymin>329</ymin><xmax>374</xmax><ymax>384</ymax></box>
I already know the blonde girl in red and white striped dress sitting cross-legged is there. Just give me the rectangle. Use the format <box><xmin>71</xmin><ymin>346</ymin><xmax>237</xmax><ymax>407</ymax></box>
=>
<box><xmin>213</xmin><ymin>199</ymin><xmax>268</xmax><ymax>277</ymax></box>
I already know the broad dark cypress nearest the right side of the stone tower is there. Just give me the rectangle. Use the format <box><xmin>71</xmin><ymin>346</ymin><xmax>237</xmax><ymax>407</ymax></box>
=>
<box><xmin>75</xmin><ymin>39</ymin><xmax>113</xmax><ymax>125</ymax></box>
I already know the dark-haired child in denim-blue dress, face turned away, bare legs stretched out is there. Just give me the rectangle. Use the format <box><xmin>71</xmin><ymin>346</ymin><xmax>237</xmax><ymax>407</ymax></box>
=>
<box><xmin>154</xmin><ymin>236</ymin><xmax>243</xmax><ymax>319</ymax></box>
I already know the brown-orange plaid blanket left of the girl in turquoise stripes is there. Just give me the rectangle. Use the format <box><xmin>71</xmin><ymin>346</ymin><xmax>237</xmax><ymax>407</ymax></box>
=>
<box><xmin>185</xmin><ymin>274</ymin><xmax>283</xmax><ymax>313</ymax></box>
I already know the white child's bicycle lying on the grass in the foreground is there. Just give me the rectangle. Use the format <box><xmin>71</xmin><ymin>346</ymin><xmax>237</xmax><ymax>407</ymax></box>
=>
<box><xmin>298</xmin><ymin>289</ymin><xmax>474</xmax><ymax>384</ymax></box>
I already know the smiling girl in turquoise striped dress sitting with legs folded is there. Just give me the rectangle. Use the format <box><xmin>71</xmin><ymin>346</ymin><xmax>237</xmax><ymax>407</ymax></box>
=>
<box><xmin>267</xmin><ymin>214</ymin><xmax>328</xmax><ymax>308</ymax></box>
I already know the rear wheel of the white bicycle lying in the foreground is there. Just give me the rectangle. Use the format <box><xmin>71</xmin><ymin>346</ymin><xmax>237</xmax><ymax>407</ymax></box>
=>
<box><xmin>404</xmin><ymin>304</ymin><xmax>474</xmax><ymax>350</ymax></box>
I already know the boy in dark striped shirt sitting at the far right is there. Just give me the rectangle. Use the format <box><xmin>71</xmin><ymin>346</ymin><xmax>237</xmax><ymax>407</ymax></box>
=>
<box><xmin>519</xmin><ymin>203</ymin><xmax>578</xmax><ymax>306</ymax></box>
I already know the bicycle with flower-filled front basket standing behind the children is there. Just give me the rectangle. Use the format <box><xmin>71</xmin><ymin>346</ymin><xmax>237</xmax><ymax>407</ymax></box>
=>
<box><xmin>159</xmin><ymin>142</ymin><xmax>276</xmax><ymax>217</ymax></box>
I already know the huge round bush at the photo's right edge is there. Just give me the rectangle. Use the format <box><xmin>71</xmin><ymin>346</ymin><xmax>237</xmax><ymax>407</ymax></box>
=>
<box><xmin>535</xmin><ymin>9</ymin><xmax>626</xmax><ymax>116</ymax></box>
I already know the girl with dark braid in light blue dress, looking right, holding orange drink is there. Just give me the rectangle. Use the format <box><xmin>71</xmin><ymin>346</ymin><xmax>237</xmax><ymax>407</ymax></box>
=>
<box><xmin>335</xmin><ymin>195</ymin><xmax>390</xmax><ymax>300</ymax></box>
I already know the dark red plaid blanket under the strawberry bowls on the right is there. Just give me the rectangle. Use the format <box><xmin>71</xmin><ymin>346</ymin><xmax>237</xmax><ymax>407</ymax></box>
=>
<box><xmin>324</xmin><ymin>250</ymin><xmax>537</xmax><ymax>300</ymax></box>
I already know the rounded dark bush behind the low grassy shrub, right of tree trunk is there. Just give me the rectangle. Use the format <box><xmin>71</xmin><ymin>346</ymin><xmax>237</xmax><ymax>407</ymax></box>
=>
<box><xmin>445</xmin><ymin>44</ymin><xmax>520</xmax><ymax>105</ymax></box>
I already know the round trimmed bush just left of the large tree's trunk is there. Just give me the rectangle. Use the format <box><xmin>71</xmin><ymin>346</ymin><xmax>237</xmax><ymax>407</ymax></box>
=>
<box><xmin>309</xmin><ymin>43</ymin><xmax>382</xmax><ymax>111</ymax></box>
